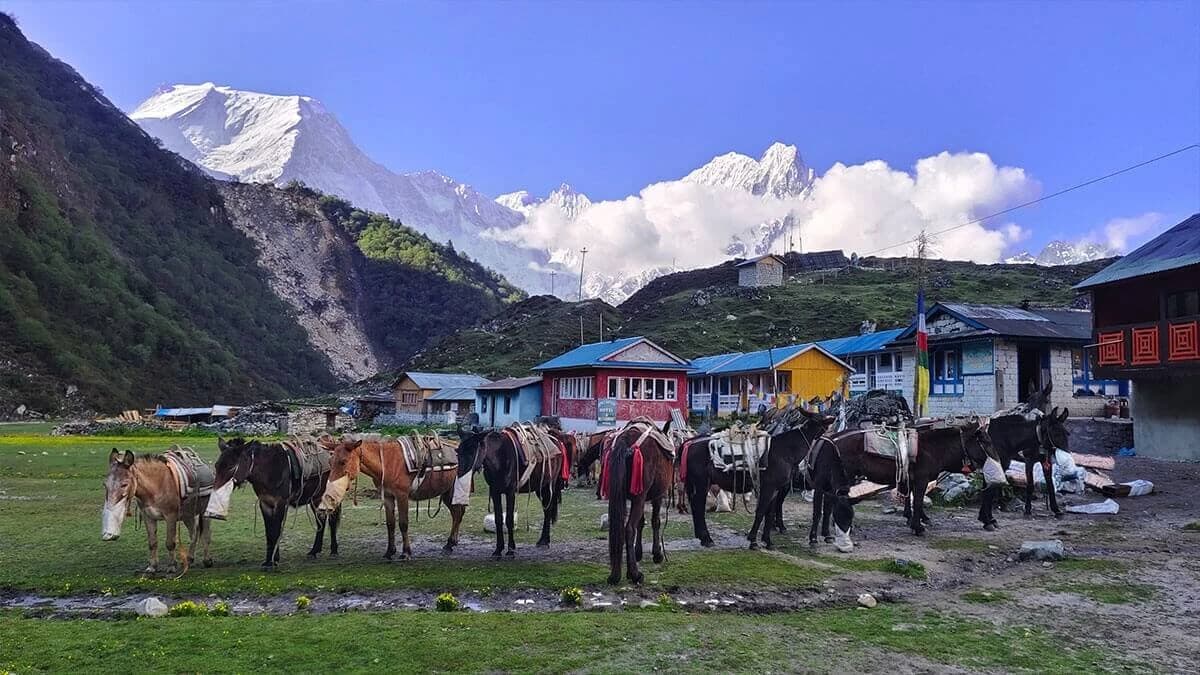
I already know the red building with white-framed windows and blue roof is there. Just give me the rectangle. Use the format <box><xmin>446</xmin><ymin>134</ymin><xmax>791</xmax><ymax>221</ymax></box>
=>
<box><xmin>533</xmin><ymin>338</ymin><xmax>690</xmax><ymax>431</ymax></box>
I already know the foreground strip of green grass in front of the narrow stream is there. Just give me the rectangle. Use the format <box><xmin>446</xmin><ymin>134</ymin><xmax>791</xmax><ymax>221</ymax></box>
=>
<box><xmin>0</xmin><ymin>605</ymin><xmax>1121</xmax><ymax>673</ymax></box>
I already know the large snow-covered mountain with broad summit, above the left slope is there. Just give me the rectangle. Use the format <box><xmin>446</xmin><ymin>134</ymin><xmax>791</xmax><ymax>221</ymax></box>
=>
<box><xmin>130</xmin><ymin>83</ymin><xmax>551</xmax><ymax>293</ymax></box>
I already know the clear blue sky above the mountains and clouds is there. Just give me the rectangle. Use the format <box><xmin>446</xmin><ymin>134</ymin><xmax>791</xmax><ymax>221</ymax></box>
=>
<box><xmin>0</xmin><ymin>0</ymin><xmax>1200</xmax><ymax>250</ymax></box>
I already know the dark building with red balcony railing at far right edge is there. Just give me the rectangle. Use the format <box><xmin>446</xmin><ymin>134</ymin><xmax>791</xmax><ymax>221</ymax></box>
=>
<box><xmin>1075</xmin><ymin>214</ymin><xmax>1200</xmax><ymax>460</ymax></box>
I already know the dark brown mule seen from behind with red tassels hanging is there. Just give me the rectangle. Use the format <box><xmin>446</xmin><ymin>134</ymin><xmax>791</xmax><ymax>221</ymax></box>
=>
<box><xmin>600</xmin><ymin>423</ymin><xmax>674</xmax><ymax>584</ymax></box>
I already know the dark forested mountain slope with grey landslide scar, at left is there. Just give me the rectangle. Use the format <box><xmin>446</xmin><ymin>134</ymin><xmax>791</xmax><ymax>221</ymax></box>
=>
<box><xmin>0</xmin><ymin>14</ymin><xmax>523</xmax><ymax>417</ymax></box>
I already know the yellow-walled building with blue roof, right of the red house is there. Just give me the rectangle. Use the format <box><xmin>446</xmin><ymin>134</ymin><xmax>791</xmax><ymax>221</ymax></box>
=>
<box><xmin>688</xmin><ymin>342</ymin><xmax>853</xmax><ymax>416</ymax></box>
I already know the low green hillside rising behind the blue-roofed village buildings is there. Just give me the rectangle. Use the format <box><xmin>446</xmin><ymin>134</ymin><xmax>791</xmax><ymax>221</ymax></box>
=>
<box><xmin>410</xmin><ymin>258</ymin><xmax>1109</xmax><ymax>376</ymax></box>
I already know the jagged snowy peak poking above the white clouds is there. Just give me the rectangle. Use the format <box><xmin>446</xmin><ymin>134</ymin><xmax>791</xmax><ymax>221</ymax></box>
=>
<box><xmin>684</xmin><ymin>143</ymin><xmax>815</xmax><ymax>197</ymax></box>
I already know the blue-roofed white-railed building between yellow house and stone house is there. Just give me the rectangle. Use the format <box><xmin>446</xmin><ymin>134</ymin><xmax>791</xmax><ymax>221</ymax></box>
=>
<box><xmin>817</xmin><ymin>324</ymin><xmax>917</xmax><ymax>407</ymax></box>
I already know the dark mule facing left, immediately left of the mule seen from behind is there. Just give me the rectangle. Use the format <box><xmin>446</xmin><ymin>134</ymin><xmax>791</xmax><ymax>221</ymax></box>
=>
<box><xmin>458</xmin><ymin>430</ymin><xmax>575</xmax><ymax>557</ymax></box>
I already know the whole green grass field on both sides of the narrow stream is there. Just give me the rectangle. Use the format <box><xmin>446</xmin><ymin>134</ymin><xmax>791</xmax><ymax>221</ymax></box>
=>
<box><xmin>0</xmin><ymin>425</ymin><xmax>1133</xmax><ymax>671</ymax></box>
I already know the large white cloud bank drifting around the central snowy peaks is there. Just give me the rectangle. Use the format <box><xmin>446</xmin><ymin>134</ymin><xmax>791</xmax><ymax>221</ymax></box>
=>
<box><xmin>485</xmin><ymin>153</ymin><xmax>1039</xmax><ymax>274</ymax></box>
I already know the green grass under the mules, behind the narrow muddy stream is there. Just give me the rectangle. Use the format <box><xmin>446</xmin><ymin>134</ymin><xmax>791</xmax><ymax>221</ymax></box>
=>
<box><xmin>0</xmin><ymin>436</ymin><xmax>832</xmax><ymax>596</ymax></box>
